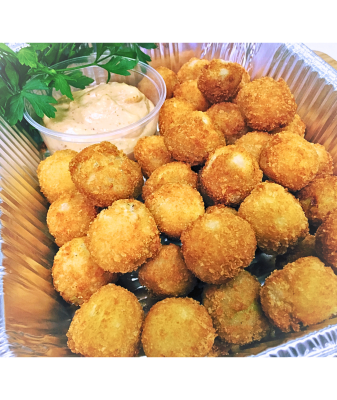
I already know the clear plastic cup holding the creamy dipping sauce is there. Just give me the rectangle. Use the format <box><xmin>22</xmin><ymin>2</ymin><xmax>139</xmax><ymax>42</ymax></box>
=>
<box><xmin>24</xmin><ymin>54</ymin><xmax>166</xmax><ymax>158</ymax></box>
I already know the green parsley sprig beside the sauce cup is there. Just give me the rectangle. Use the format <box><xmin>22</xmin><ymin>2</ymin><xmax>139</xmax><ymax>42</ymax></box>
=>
<box><xmin>0</xmin><ymin>43</ymin><xmax>156</xmax><ymax>125</ymax></box>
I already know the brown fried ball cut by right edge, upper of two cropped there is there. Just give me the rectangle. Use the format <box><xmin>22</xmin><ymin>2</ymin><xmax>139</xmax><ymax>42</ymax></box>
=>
<box><xmin>296</xmin><ymin>175</ymin><xmax>337</xmax><ymax>227</ymax></box>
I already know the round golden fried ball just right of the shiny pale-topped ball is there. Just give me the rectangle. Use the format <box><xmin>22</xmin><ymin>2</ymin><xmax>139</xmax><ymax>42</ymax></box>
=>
<box><xmin>260</xmin><ymin>132</ymin><xmax>319</xmax><ymax>192</ymax></box>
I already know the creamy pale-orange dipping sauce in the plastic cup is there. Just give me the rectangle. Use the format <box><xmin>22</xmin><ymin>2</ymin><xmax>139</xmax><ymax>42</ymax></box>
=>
<box><xmin>43</xmin><ymin>82</ymin><xmax>154</xmax><ymax>135</ymax></box>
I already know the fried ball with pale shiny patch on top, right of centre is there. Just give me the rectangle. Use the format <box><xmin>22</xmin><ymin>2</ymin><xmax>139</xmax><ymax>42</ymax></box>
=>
<box><xmin>200</xmin><ymin>146</ymin><xmax>263</xmax><ymax>206</ymax></box>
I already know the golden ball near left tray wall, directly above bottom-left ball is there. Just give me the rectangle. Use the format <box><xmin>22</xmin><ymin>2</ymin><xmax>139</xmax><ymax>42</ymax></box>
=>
<box><xmin>52</xmin><ymin>237</ymin><xmax>118</xmax><ymax>306</ymax></box>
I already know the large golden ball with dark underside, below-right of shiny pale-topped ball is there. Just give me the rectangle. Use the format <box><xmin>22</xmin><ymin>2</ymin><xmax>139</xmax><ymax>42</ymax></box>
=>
<box><xmin>238</xmin><ymin>182</ymin><xmax>309</xmax><ymax>255</ymax></box>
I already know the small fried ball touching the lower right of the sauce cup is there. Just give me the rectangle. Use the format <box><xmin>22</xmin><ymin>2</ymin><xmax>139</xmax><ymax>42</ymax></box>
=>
<box><xmin>134</xmin><ymin>136</ymin><xmax>173</xmax><ymax>178</ymax></box>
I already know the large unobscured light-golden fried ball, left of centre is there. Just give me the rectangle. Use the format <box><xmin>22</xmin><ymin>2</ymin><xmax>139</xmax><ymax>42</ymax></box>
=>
<box><xmin>87</xmin><ymin>200</ymin><xmax>160</xmax><ymax>273</ymax></box>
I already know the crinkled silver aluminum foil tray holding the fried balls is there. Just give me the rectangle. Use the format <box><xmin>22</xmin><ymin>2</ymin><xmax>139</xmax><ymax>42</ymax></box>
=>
<box><xmin>0</xmin><ymin>43</ymin><xmax>337</xmax><ymax>357</ymax></box>
